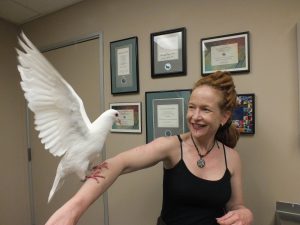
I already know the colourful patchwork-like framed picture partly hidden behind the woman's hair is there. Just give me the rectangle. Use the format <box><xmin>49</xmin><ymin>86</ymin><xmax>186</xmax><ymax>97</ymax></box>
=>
<box><xmin>232</xmin><ymin>94</ymin><xmax>255</xmax><ymax>134</ymax></box>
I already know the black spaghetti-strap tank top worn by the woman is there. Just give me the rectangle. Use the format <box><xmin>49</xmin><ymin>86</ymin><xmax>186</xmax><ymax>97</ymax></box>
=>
<box><xmin>161</xmin><ymin>135</ymin><xmax>231</xmax><ymax>225</ymax></box>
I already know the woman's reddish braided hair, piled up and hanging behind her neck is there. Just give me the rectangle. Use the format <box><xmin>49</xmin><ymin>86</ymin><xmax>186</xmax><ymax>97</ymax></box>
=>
<box><xmin>192</xmin><ymin>71</ymin><xmax>240</xmax><ymax>148</ymax></box>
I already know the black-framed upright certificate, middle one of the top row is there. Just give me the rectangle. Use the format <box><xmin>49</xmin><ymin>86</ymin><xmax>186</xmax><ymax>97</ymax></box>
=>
<box><xmin>151</xmin><ymin>28</ymin><xmax>186</xmax><ymax>78</ymax></box>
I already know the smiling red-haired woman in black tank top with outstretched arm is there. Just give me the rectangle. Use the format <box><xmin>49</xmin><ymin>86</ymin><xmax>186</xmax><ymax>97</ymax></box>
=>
<box><xmin>46</xmin><ymin>72</ymin><xmax>253</xmax><ymax>225</ymax></box>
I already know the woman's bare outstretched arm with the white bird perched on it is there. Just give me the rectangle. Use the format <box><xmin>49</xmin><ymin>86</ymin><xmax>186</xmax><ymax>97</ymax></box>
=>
<box><xmin>46</xmin><ymin>137</ymin><xmax>177</xmax><ymax>225</ymax></box>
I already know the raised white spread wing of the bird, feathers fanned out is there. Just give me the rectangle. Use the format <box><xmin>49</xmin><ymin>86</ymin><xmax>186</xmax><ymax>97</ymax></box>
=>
<box><xmin>17</xmin><ymin>33</ymin><xmax>91</xmax><ymax>156</ymax></box>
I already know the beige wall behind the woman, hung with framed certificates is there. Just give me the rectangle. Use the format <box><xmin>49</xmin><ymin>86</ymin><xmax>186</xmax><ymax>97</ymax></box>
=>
<box><xmin>1</xmin><ymin>0</ymin><xmax>300</xmax><ymax>225</ymax></box>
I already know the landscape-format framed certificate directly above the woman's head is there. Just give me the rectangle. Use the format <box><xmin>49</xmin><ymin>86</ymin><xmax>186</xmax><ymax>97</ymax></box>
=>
<box><xmin>201</xmin><ymin>32</ymin><xmax>250</xmax><ymax>75</ymax></box>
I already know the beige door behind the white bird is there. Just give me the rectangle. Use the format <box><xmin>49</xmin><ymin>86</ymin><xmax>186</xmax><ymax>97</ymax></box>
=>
<box><xmin>29</xmin><ymin>38</ymin><xmax>105</xmax><ymax>225</ymax></box>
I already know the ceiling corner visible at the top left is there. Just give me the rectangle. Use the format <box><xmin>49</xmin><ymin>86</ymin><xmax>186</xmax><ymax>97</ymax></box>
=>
<box><xmin>0</xmin><ymin>0</ymin><xmax>84</xmax><ymax>25</ymax></box>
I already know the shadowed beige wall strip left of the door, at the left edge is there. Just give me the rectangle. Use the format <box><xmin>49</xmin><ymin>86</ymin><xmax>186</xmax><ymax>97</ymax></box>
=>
<box><xmin>0</xmin><ymin>20</ymin><xmax>30</xmax><ymax>225</ymax></box>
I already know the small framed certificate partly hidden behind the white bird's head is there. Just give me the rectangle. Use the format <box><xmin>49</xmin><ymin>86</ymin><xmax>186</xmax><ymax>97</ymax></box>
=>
<box><xmin>110</xmin><ymin>102</ymin><xmax>142</xmax><ymax>133</ymax></box>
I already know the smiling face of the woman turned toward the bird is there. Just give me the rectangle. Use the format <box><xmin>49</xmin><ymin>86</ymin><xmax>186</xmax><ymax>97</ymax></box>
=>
<box><xmin>187</xmin><ymin>85</ymin><xmax>230</xmax><ymax>138</ymax></box>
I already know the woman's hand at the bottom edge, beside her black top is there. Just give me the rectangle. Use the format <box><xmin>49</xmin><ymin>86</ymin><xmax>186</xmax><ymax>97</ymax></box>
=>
<box><xmin>217</xmin><ymin>208</ymin><xmax>253</xmax><ymax>225</ymax></box>
